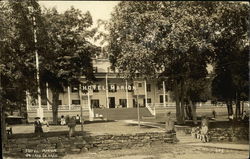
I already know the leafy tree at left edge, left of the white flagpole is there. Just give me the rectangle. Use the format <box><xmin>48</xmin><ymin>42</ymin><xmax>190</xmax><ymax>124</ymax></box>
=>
<box><xmin>0</xmin><ymin>1</ymin><xmax>38</xmax><ymax>143</ymax></box>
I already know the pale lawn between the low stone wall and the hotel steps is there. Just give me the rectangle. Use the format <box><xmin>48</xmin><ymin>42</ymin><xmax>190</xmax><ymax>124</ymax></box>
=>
<box><xmin>7</xmin><ymin>120</ymin><xmax>162</xmax><ymax>137</ymax></box>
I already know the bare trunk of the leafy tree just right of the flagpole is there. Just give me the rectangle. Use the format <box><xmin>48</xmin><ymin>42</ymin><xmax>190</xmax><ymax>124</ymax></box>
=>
<box><xmin>52</xmin><ymin>90</ymin><xmax>59</xmax><ymax>124</ymax></box>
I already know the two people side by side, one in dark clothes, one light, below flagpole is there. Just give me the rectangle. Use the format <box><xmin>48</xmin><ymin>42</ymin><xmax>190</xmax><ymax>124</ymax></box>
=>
<box><xmin>34</xmin><ymin>117</ymin><xmax>49</xmax><ymax>136</ymax></box>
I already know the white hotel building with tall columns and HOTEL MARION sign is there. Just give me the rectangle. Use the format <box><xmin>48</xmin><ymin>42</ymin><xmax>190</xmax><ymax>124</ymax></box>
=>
<box><xmin>27</xmin><ymin>59</ymin><xmax>174</xmax><ymax>121</ymax></box>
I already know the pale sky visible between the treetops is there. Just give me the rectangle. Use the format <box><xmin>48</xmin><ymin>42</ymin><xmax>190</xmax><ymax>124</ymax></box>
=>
<box><xmin>38</xmin><ymin>1</ymin><xmax>119</xmax><ymax>45</ymax></box>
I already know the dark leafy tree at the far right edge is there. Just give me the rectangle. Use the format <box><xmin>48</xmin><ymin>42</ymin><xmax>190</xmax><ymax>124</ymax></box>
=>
<box><xmin>212</xmin><ymin>2</ymin><xmax>249</xmax><ymax>118</ymax></box>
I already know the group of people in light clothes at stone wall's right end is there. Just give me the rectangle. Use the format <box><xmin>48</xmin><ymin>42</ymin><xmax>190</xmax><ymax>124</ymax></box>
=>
<box><xmin>191</xmin><ymin>117</ymin><xmax>209</xmax><ymax>142</ymax></box>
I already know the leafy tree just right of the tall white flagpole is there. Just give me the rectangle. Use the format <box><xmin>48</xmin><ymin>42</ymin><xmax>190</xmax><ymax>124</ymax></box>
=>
<box><xmin>40</xmin><ymin>7</ymin><xmax>98</xmax><ymax>124</ymax></box>
